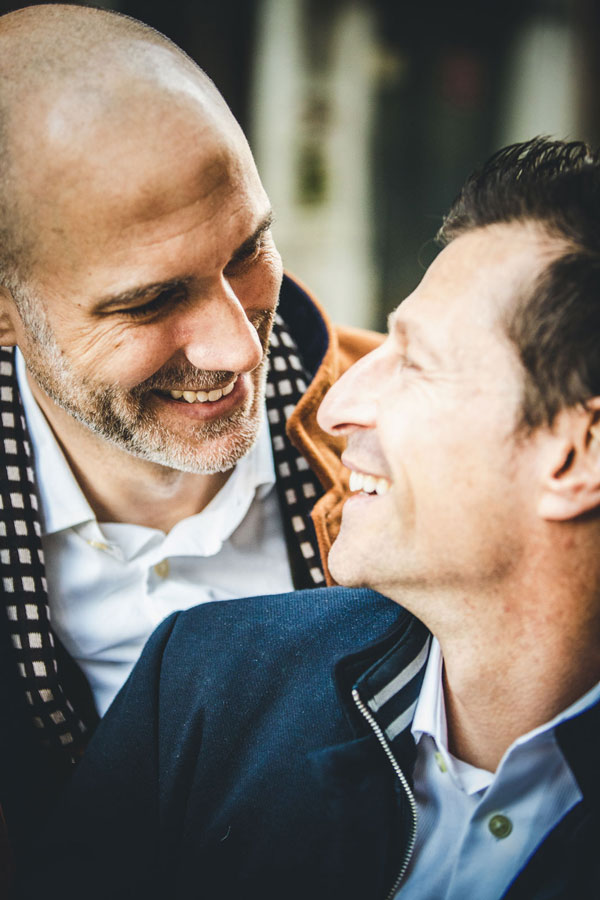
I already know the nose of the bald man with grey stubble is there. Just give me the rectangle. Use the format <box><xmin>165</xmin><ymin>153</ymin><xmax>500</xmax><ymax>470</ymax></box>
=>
<box><xmin>177</xmin><ymin>279</ymin><xmax>263</xmax><ymax>373</ymax></box>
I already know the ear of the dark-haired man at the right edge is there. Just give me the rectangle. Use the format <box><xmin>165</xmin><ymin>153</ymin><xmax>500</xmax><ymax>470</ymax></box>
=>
<box><xmin>538</xmin><ymin>397</ymin><xmax>600</xmax><ymax>521</ymax></box>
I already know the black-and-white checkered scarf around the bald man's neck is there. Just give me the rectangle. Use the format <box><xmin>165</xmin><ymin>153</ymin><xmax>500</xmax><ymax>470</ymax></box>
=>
<box><xmin>0</xmin><ymin>315</ymin><xmax>325</xmax><ymax>762</ymax></box>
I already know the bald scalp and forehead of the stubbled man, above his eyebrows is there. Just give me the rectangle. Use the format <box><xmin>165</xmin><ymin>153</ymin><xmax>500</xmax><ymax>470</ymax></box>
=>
<box><xmin>0</xmin><ymin>4</ymin><xmax>268</xmax><ymax>296</ymax></box>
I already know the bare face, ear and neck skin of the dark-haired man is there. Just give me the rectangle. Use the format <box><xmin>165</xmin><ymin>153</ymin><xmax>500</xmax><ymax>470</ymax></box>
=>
<box><xmin>319</xmin><ymin>222</ymin><xmax>600</xmax><ymax>771</ymax></box>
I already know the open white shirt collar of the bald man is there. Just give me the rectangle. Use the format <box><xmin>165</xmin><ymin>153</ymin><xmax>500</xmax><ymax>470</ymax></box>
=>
<box><xmin>16</xmin><ymin>349</ymin><xmax>275</xmax><ymax>557</ymax></box>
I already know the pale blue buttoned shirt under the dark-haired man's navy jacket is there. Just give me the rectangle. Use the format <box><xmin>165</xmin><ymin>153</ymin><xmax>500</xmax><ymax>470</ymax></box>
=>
<box><xmin>396</xmin><ymin>639</ymin><xmax>600</xmax><ymax>900</ymax></box>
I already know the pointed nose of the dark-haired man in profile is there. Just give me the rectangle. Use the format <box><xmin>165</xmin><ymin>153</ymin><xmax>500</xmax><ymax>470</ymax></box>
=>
<box><xmin>317</xmin><ymin>344</ymin><xmax>386</xmax><ymax>435</ymax></box>
